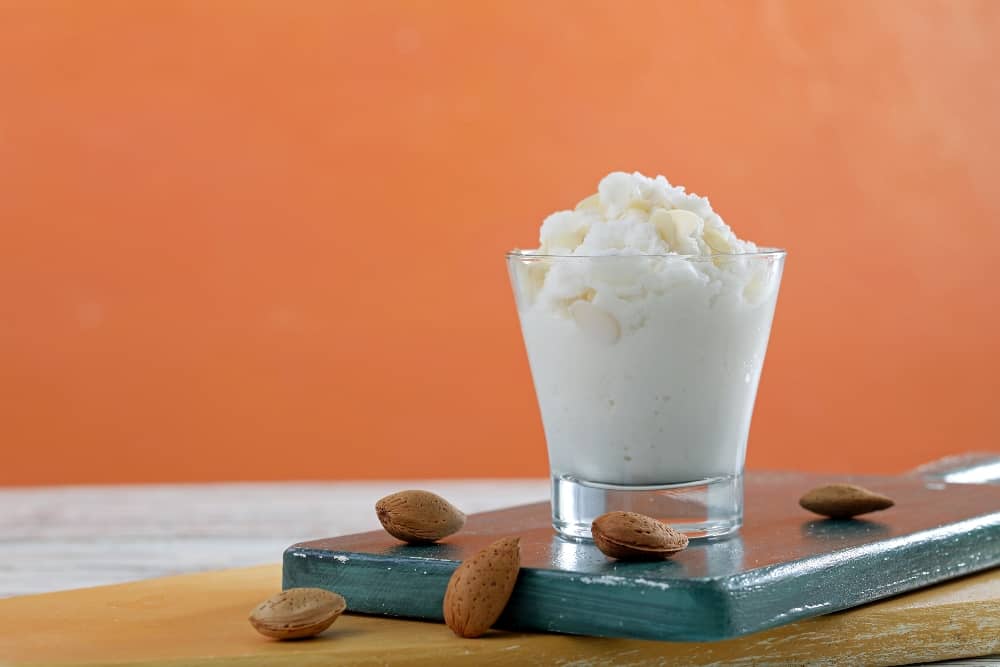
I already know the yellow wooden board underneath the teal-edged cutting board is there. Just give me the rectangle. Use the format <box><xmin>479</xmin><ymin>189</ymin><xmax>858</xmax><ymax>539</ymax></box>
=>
<box><xmin>0</xmin><ymin>565</ymin><xmax>1000</xmax><ymax>667</ymax></box>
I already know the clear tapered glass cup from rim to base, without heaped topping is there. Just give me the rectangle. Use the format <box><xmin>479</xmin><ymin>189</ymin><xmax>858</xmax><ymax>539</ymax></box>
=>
<box><xmin>507</xmin><ymin>248</ymin><xmax>785</xmax><ymax>540</ymax></box>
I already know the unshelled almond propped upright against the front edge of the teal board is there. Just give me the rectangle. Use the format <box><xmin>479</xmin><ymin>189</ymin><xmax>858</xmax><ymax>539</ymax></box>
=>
<box><xmin>444</xmin><ymin>537</ymin><xmax>521</xmax><ymax>637</ymax></box>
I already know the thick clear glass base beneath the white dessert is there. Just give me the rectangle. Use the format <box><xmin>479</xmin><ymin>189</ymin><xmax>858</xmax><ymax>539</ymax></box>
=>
<box><xmin>552</xmin><ymin>474</ymin><xmax>743</xmax><ymax>541</ymax></box>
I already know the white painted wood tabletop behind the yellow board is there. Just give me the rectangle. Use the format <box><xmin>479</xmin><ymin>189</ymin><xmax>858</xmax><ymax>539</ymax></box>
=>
<box><xmin>0</xmin><ymin>479</ymin><xmax>1000</xmax><ymax>667</ymax></box>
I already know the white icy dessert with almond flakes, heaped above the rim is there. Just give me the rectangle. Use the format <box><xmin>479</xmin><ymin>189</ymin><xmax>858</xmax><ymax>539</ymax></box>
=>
<box><xmin>510</xmin><ymin>173</ymin><xmax>784</xmax><ymax>485</ymax></box>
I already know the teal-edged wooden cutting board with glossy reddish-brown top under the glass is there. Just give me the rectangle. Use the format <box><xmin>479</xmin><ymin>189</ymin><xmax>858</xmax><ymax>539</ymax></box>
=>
<box><xmin>283</xmin><ymin>460</ymin><xmax>1000</xmax><ymax>641</ymax></box>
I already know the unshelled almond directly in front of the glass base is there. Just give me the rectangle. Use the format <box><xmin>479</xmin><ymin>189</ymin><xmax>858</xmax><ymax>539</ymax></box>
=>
<box><xmin>590</xmin><ymin>512</ymin><xmax>688</xmax><ymax>560</ymax></box>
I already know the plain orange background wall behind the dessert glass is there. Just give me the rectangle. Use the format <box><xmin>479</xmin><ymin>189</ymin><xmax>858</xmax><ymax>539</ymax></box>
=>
<box><xmin>0</xmin><ymin>0</ymin><xmax>1000</xmax><ymax>484</ymax></box>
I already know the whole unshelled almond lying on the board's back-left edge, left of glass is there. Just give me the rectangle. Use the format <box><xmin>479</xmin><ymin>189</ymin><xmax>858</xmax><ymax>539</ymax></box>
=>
<box><xmin>375</xmin><ymin>490</ymin><xmax>465</xmax><ymax>544</ymax></box>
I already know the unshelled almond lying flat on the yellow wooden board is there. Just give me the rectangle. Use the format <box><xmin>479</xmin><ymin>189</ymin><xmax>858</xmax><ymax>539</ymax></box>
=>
<box><xmin>250</xmin><ymin>588</ymin><xmax>347</xmax><ymax>639</ymax></box>
